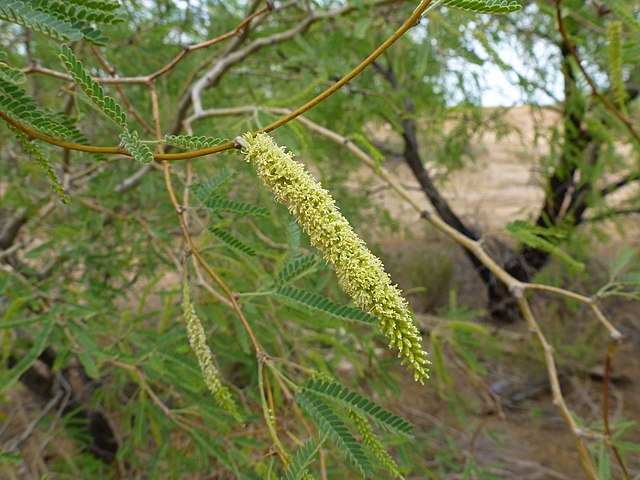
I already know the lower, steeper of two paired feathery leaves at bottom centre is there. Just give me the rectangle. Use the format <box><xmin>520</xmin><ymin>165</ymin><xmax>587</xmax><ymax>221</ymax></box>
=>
<box><xmin>296</xmin><ymin>390</ymin><xmax>371</xmax><ymax>477</ymax></box>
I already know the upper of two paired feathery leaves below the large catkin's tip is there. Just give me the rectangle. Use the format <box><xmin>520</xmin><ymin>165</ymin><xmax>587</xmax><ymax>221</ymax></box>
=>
<box><xmin>303</xmin><ymin>380</ymin><xmax>414</xmax><ymax>437</ymax></box>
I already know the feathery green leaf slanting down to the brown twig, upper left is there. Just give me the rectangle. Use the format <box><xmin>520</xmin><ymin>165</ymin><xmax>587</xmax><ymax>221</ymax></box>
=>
<box><xmin>59</xmin><ymin>44</ymin><xmax>127</xmax><ymax>127</ymax></box>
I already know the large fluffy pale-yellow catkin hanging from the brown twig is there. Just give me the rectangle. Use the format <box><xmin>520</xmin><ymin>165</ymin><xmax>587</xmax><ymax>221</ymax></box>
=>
<box><xmin>238</xmin><ymin>133</ymin><xmax>430</xmax><ymax>383</ymax></box>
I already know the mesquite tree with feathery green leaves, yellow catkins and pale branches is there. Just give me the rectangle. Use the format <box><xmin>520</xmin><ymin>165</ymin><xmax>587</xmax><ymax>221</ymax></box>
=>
<box><xmin>0</xmin><ymin>0</ymin><xmax>638</xmax><ymax>478</ymax></box>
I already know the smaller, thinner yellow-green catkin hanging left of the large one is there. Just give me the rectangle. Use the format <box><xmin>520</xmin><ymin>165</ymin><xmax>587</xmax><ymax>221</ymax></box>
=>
<box><xmin>182</xmin><ymin>279</ymin><xmax>242</xmax><ymax>421</ymax></box>
